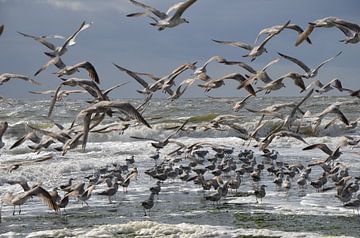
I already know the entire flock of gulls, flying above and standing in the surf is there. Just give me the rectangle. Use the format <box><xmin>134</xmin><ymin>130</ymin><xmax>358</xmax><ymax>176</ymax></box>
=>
<box><xmin>0</xmin><ymin>0</ymin><xmax>360</xmax><ymax>219</ymax></box>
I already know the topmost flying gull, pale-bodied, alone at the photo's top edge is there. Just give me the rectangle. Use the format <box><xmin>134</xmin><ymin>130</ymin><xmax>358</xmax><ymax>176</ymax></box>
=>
<box><xmin>126</xmin><ymin>0</ymin><xmax>196</xmax><ymax>31</ymax></box>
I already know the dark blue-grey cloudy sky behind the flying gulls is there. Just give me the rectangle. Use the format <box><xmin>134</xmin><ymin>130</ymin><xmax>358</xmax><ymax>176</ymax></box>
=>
<box><xmin>0</xmin><ymin>0</ymin><xmax>360</xmax><ymax>99</ymax></box>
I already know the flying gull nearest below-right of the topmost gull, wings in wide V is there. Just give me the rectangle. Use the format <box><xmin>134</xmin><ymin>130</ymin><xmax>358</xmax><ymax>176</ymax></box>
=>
<box><xmin>213</xmin><ymin>21</ymin><xmax>290</xmax><ymax>61</ymax></box>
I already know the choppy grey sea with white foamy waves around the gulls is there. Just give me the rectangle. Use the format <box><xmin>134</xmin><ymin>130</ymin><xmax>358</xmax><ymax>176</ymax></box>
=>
<box><xmin>0</xmin><ymin>96</ymin><xmax>360</xmax><ymax>237</ymax></box>
